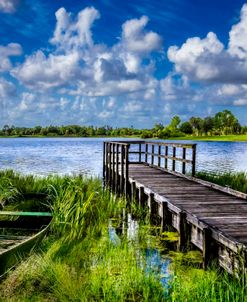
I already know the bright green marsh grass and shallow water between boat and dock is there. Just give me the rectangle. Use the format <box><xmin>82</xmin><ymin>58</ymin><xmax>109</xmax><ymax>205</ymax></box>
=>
<box><xmin>0</xmin><ymin>171</ymin><xmax>247</xmax><ymax>302</ymax></box>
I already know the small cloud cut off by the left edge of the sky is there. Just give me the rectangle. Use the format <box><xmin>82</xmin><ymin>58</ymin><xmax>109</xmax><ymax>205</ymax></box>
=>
<box><xmin>0</xmin><ymin>43</ymin><xmax>22</xmax><ymax>72</ymax></box>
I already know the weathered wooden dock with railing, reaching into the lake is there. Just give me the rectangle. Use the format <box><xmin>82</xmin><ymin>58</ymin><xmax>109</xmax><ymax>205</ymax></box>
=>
<box><xmin>103</xmin><ymin>141</ymin><xmax>247</xmax><ymax>274</ymax></box>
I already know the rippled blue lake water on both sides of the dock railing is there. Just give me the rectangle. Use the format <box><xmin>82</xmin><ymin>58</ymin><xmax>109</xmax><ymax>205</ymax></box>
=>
<box><xmin>0</xmin><ymin>138</ymin><xmax>247</xmax><ymax>176</ymax></box>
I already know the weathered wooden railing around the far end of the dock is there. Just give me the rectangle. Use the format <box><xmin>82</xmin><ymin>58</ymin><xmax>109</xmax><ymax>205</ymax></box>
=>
<box><xmin>103</xmin><ymin>141</ymin><xmax>196</xmax><ymax>192</ymax></box>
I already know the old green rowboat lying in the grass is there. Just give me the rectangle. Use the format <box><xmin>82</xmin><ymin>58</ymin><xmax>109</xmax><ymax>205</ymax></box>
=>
<box><xmin>0</xmin><ymin>211</ymin><xmax>52</xmax><ymax>278</ymax></box>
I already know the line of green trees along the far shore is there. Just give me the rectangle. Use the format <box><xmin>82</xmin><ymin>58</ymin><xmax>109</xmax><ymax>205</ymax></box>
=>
<box><xmin>0</xmin><ymin>110</ymin><xmax>247</xmax><ymax>138</ymax></box>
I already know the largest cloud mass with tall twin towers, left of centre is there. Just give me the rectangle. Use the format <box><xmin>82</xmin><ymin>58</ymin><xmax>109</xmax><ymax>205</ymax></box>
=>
<box><xmin>11</xmin><ymin>7</ymin><xmax>162</xmax><ymax>98</ymax></box>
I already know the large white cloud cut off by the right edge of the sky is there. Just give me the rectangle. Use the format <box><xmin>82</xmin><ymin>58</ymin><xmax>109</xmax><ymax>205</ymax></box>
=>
<box><xmin>168</xmin><ymin>4</ymin><xmax>247</xmax><ymax>84</ymax></box>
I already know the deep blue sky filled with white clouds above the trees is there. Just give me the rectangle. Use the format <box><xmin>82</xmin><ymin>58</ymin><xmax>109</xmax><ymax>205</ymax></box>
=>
<box><xmin>0</xmin><ymin>0</ymin><xmax>247</xmax><ymax>128</ymax></box>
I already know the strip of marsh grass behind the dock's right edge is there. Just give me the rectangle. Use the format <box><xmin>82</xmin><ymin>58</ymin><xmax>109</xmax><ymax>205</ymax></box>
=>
<box><xmin>196</xmin><ymin>172</ymin><xmax>247</xmax><ymax>193</ymax></box>
